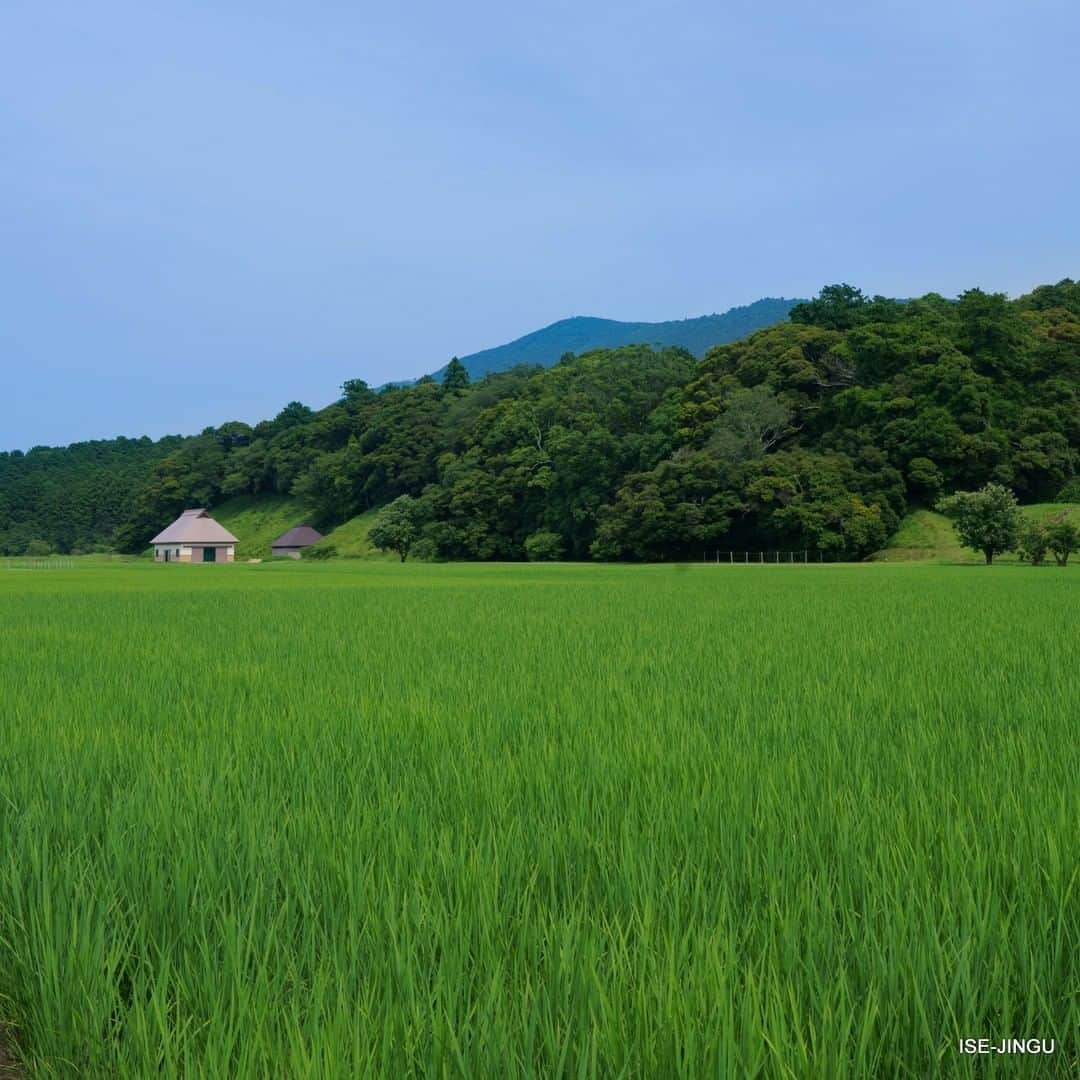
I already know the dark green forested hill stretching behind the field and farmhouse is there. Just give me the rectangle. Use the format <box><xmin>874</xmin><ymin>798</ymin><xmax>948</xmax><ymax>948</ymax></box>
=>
<box><xmin>0</xmin><ymin>280</ymin><xmax>1080</xmax><ymax>559</ymax></box>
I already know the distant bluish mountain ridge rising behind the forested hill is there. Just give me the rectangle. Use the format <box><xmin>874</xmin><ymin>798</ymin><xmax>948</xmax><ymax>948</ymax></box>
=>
<box><xmin>435</xmin><ymin>297</ymin><xmax>802</xmax><ymax>379</ymax></box>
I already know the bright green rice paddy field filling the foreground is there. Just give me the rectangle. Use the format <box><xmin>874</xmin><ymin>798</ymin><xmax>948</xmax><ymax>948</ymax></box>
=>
<box><xmin>0</xmin><ymin>563</ymin><xmax>1080</xmax><ymax>1078</ymax></box>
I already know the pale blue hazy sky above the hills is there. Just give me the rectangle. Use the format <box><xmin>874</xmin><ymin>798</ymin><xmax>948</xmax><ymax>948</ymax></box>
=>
<box><xmin>0</xmin><ymin>0</ymin><xmax>1080</xmax><ymax>448</ymax></box>
